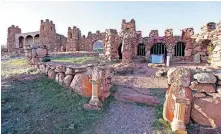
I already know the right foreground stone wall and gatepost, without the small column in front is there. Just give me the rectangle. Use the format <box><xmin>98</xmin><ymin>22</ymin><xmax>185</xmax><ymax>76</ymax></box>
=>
<box><xmin>163</xmin><ymin>68</ymin><xmax>221</xmax><ymax>128</ymax></box>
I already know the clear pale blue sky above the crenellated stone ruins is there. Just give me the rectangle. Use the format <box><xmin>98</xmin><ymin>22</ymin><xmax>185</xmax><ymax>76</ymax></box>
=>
<box><xmin>0</xmin><ymin>1</ymin><xmax>221</xmax><ymax>44</ymax></box>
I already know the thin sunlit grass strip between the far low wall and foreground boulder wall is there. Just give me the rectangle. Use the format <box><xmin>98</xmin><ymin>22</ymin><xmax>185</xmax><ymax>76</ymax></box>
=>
<box><xmin>51</xmin><ymin>56</ymin><xmax>96</xmax><ymax>64</ymax></box>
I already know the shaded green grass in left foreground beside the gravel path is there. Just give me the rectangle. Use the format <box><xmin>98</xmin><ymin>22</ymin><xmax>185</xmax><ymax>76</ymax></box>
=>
<box><xmin>1</xmin><ymin>77</ymin><xmax>113</xmax><ymax>134</ymax></box>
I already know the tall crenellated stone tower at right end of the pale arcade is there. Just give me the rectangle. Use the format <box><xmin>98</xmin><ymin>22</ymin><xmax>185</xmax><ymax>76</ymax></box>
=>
<box><xmin>40</xmin><ymin>19</ymin><xmax>59</xmax><ymax>51</ymax></box>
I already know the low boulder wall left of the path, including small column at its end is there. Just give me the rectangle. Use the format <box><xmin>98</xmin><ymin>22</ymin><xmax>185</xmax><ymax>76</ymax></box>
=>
<box><xmin>35</xmin><ymin>62</ymin><xmax>112</xmax><ymax>110</ymax></box>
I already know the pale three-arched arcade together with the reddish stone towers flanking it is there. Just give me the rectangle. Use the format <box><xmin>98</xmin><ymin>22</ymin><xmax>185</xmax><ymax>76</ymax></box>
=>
<box><xmin>7</xmin><ymin>19</ymin><xmax>67</xmax><ymax>52</ymax></box>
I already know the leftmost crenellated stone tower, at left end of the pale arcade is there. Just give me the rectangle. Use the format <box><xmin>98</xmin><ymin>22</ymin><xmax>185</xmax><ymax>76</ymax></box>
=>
<box><xmin>7</xmin><ymin>25</ymin><xmax>21</xmax><ymax>52</ymax></box>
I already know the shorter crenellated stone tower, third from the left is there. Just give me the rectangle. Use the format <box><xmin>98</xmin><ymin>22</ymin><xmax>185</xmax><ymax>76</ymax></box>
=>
<box><xmin>66</xmin><ymin>26</ymin><xmax>81</xmax><ymax>51</ymax></box>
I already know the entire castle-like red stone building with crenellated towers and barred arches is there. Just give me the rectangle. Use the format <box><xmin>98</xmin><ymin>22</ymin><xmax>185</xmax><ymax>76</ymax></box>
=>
<box><xmin>7</xmin><ymin>19</ymin><xmax>220</xmax><ymax>67</ymax></box>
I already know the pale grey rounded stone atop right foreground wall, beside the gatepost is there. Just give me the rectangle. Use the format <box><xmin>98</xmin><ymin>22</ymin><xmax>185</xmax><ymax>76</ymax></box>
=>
<box><xmin>193</xmin><ymin>73</ymin><xmax>216</xmax><ymax>83</ymax></box>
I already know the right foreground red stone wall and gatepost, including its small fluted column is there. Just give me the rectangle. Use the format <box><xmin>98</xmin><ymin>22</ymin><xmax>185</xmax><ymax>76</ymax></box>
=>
<box><xmin>163</xmin><ymin>68</ymin><xmax>221</xmax><ymax>133</ymax></box>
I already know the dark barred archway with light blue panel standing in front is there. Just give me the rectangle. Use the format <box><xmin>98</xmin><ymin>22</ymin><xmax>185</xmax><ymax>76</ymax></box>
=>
<box><xmin>150</xmin><ymin>43</ymin><xmax>167</xmax><ymax>63</ymax></box>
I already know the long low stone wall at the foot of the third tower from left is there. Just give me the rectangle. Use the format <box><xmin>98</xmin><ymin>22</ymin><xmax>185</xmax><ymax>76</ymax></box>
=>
<box><xmin>49</xmin><ymin>51</ymin><xmax>99</xmax><ymax>57</ymax></box>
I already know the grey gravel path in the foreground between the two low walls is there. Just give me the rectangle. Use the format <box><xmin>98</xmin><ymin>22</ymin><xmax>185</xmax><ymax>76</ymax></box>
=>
<box><xmin>93</xmin><ymin>101</ymin><xmax>155</xmax><ymax>134</ymax></box>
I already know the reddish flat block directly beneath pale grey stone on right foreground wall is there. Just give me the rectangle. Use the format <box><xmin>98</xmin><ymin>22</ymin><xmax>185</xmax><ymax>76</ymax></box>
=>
<box><xmin>190</xmin><ymin>81</ymin><xmax>216</xmax><ymax>93</ymax></box>
